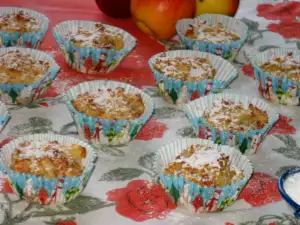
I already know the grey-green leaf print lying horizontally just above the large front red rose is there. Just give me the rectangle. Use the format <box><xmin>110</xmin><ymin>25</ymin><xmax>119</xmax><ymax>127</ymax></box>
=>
<box><xmin>99</xmin><ymin>168</ymin><xmax>145</xmax><ymax>181</ymax></box>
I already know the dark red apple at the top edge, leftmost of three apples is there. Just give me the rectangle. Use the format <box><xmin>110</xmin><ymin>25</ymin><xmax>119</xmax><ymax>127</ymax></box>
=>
<box><xmin>96</xmin><ymin>0</ymin><xmax>131</xmax><ymax>18</ymax></box>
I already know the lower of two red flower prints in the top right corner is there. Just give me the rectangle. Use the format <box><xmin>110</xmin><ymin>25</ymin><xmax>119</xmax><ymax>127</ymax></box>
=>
<box><xmin>267</xmin><ymin>21</ymin><xmax>300</xmax><ymax>39</ymax></box>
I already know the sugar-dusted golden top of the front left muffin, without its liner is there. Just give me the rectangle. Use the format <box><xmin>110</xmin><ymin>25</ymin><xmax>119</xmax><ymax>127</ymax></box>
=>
<box><xmin>10</xmin><ymin>141</ymin><xmax>87</xmax><ymax>178</ymax></box>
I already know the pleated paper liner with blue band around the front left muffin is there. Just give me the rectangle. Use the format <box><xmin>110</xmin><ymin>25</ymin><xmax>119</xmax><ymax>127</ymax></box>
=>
<box><xmin>0</xmin><ymin>134</ymin><xmax>97</xmax><ymax>205</ymax></box>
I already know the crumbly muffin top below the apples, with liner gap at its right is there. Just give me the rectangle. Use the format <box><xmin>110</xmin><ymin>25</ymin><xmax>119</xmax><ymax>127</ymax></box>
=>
<box><xmin>153</xmin><ymin>56</ymin><xmax>216</xmax><ymax>82</ymax></box>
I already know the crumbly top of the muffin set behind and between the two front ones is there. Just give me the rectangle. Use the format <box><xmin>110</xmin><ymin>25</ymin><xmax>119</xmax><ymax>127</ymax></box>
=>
<box><xmin>72</xmin><ymin>87</ymin><xmax>145</xmax><ymax>120</ymax></box>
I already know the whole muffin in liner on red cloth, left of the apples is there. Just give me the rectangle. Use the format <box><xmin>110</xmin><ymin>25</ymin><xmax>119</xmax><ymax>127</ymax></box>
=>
<box><xmin>52</xmin><ymin>20</ymin><xmax>136</xmax><ymax>74</ymax></box>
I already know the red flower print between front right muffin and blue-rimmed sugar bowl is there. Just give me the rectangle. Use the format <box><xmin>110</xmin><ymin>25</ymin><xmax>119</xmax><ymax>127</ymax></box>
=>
<box><xmin>238</xmin><ymin>172</ymin><xmax>282</xmax><ymax>207</ymax></box>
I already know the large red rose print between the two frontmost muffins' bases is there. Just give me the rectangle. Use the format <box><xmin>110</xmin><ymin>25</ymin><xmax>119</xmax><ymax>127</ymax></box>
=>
<box><xmin>106</xmin><ymin>180</ymin><xmax>176</xmax><ymax>222</ymax></box>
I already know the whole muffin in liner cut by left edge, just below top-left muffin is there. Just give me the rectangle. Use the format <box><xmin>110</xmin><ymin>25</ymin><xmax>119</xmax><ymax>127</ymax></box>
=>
<box><xmin>0</xmin><ymin>47</ymin><xmax>59</xmax><ymax>104</ymax></box>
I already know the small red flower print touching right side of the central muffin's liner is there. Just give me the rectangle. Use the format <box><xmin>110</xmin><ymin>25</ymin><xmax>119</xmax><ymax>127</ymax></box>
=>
<box><xmin>135</xmin><ymin>117</ymin><xmax>168</xmax><ymax>141</ymax></box>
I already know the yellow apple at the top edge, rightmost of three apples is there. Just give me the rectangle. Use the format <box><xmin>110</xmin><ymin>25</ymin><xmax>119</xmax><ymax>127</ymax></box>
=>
<box><xmin>195</xmin><ymin>0</ymin><xmax>240</xmax><ymax>17</ymax></box>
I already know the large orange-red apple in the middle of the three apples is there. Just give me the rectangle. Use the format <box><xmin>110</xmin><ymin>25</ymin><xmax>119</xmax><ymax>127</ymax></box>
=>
<box><xmin>130</xmin><ymin>0</ymin><xmax>196</xmax><ymax>40</ymax></box>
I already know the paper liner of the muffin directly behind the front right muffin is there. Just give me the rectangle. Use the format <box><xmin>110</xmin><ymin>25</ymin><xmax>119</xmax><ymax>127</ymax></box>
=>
<box><xmin>184</xmin><ymin>93</ymin><xmax>279</xmax><ymax>155</ymax></box>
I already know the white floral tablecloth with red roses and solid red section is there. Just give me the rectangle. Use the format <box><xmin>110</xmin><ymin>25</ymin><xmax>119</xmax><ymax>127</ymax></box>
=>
<box><xmin>0</xmin><ymin>0</ymin><xmax>300</xmax><ymax>225</ymax></box>
